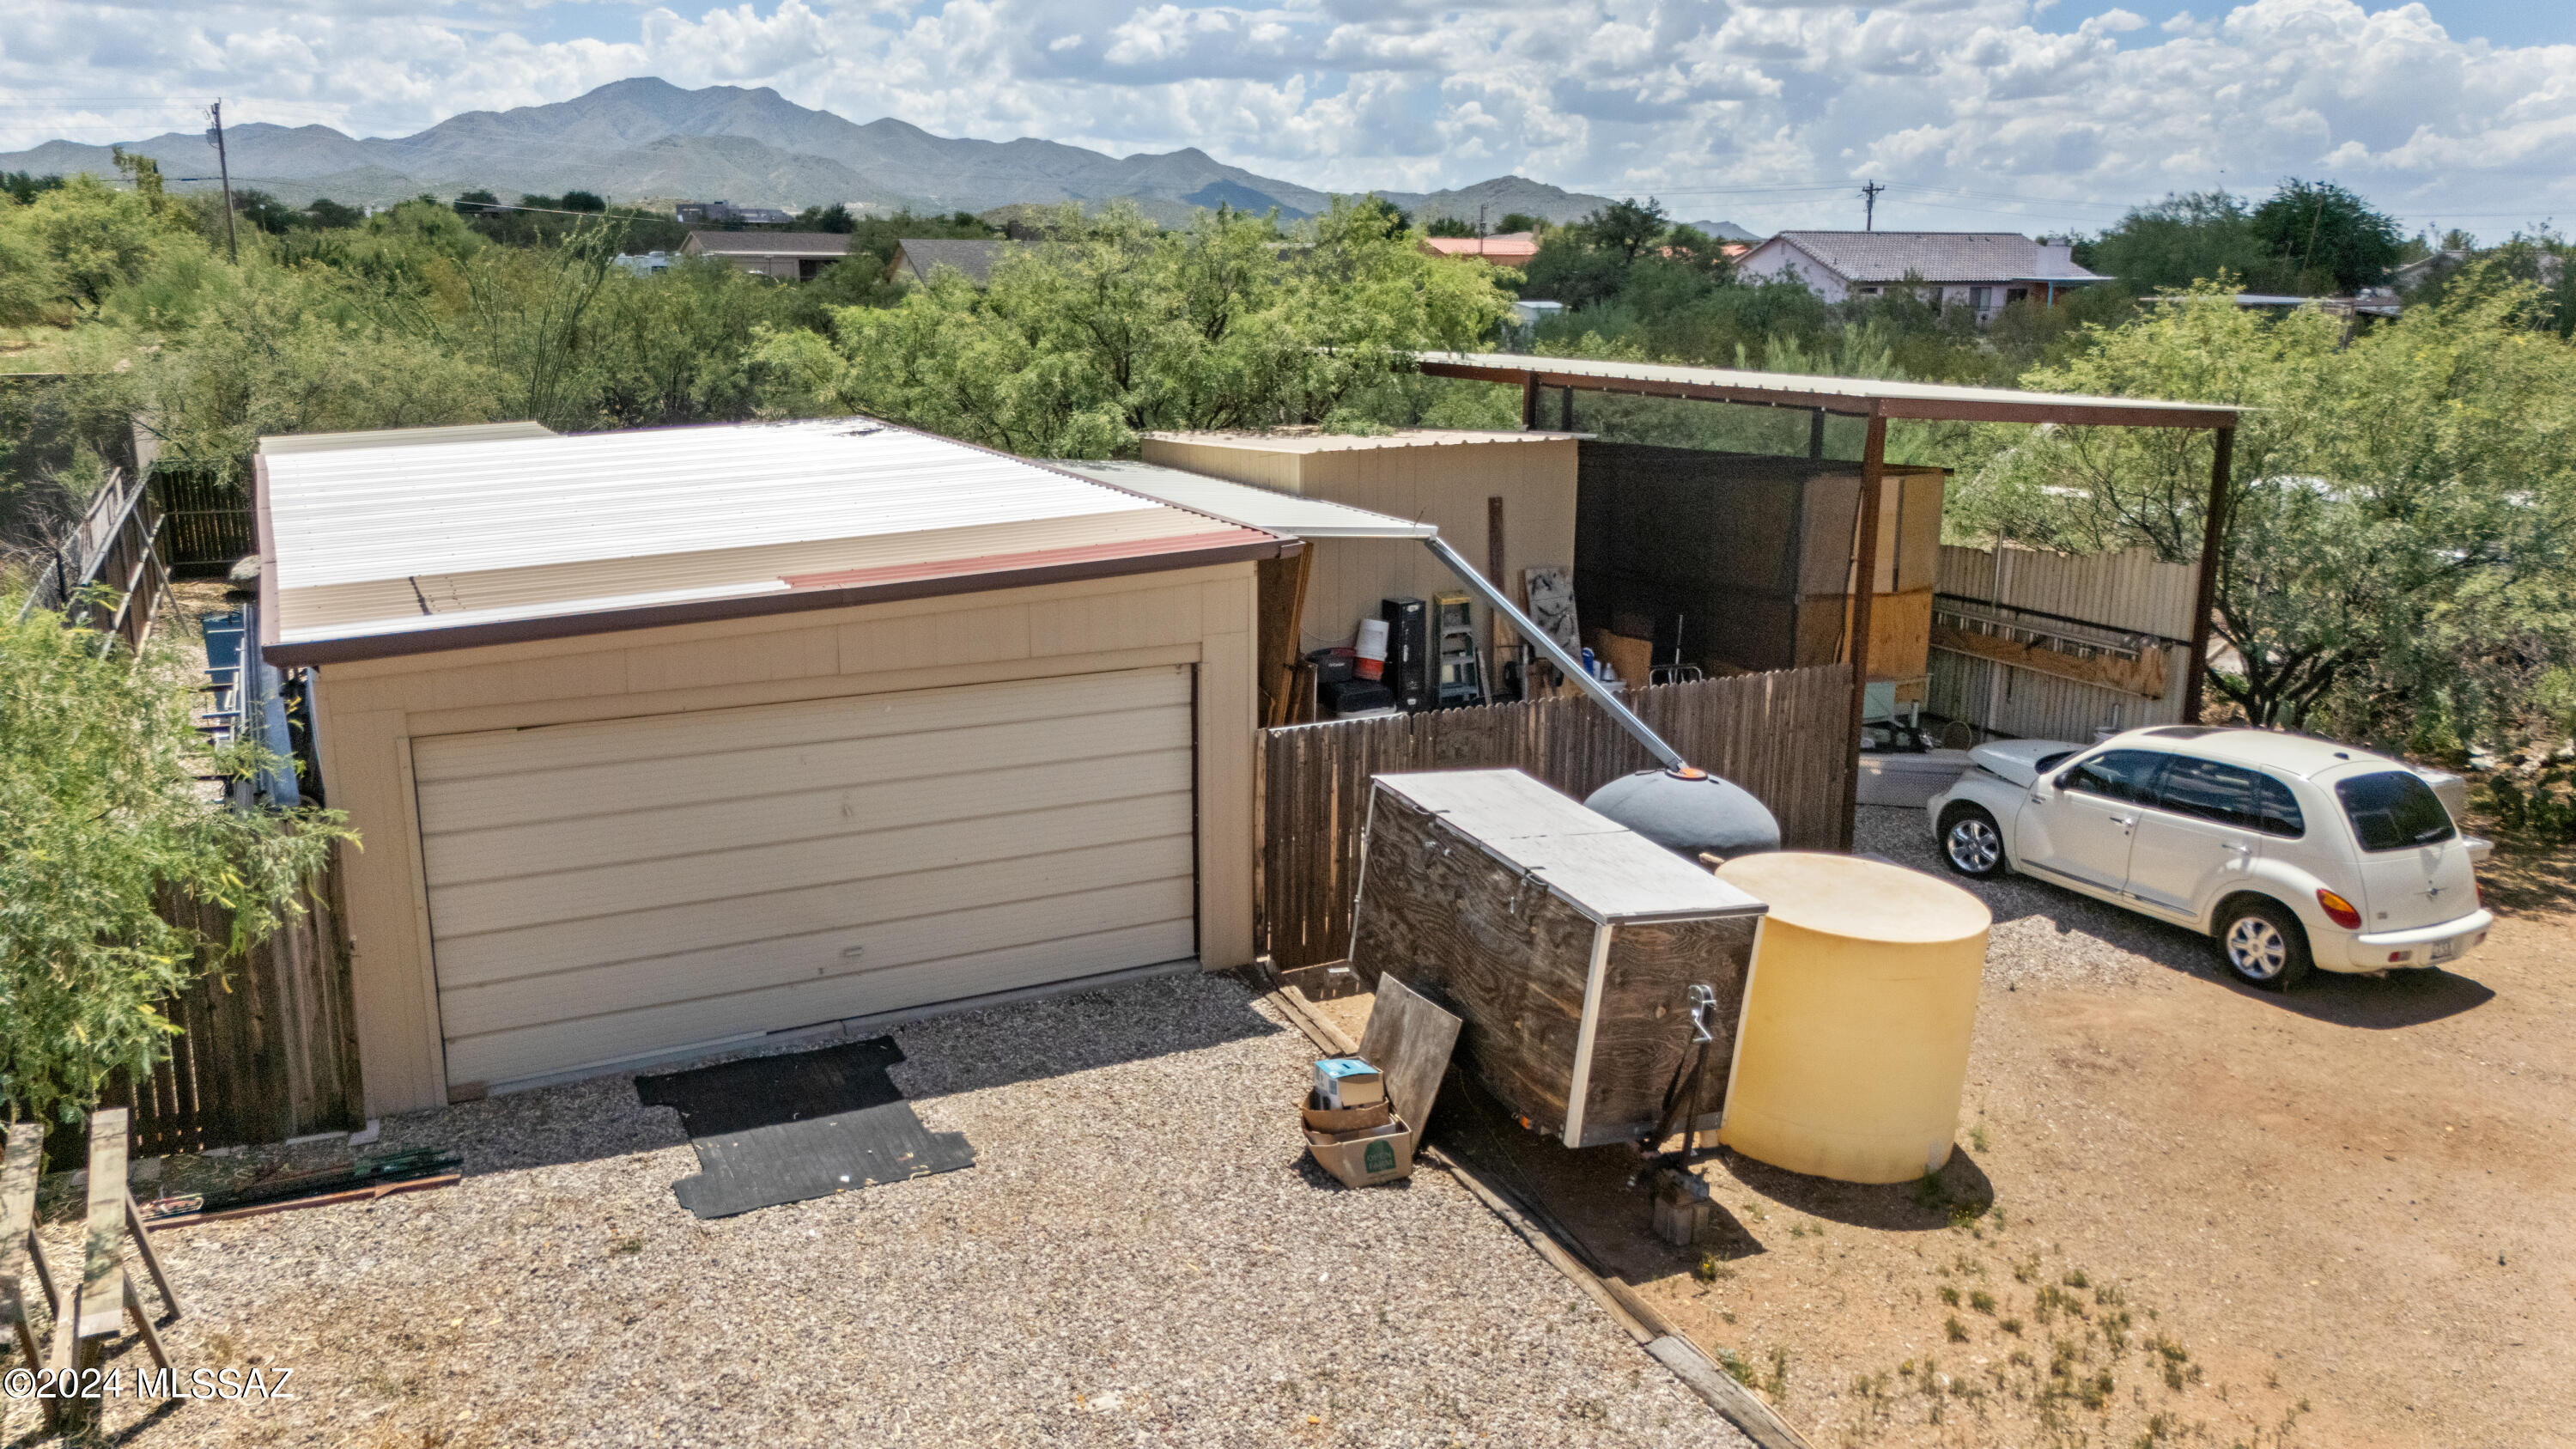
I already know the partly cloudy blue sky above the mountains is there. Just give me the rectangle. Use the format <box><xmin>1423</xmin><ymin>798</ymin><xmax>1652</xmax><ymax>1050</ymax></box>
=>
<box><xmin>0</xmin><ymin>0</ymin><xmax>2576</xmax><ymax>237</ymax></box>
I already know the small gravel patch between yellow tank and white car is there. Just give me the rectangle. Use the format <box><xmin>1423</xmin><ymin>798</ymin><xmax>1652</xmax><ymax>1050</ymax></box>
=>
<box><xmin>1852</xmin><ymin>805</ymin><xmax>2218</xmax><ymax>988</ymax></box>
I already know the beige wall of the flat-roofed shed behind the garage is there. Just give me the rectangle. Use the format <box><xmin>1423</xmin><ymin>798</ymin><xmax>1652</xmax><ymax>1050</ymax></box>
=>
<box><xmin>1144</xmin><ymin>435</ymin><xmax>1577</xmax><ymax>649</ymax></box>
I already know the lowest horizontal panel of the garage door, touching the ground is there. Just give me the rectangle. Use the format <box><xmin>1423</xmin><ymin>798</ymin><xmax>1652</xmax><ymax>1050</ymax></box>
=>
<box><xmin>448</xmin><ymin>921</ymin><xmax>1195</xmax><ymax>1083</ymax></box>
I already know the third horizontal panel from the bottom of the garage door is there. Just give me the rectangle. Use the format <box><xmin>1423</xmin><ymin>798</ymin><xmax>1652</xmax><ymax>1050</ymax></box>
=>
<box><xmin>438</xmin><ymin>836</ymin><xmax>1198</xmax><ymax>984</ymax></box>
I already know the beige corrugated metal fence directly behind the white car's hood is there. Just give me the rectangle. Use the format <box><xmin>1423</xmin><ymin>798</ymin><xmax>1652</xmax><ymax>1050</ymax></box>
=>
<box><xmin>1924</xmin><ymin>544</ymin><xmax>2197</xmax><ymax>743</ymax></box>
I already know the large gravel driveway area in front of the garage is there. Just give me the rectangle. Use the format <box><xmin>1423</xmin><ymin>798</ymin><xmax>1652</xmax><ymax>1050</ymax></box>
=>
<box><xmin>0</xmin><ymin>977</ymin><xmax>1744</xmax><ymax>1449</ymax></box>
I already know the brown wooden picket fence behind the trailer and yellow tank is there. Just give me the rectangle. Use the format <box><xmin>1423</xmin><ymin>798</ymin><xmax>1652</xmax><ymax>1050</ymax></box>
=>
<box><xmin>1260</xmin><ymin>665</ymin><xmax>1855</xmax><ymax>970</ymax></box>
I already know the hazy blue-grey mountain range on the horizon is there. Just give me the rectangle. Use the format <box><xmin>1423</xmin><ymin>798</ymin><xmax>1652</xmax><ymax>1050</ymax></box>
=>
<box><xmin>0</xmin><ymin>77</ymin><xmax>1739</xmax><ymax>232</ymax></box>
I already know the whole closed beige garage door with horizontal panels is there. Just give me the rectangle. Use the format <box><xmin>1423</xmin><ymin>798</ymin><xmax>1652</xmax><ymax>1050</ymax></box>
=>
<box><xmin>412</xmin><ymin>667</ymin><xmax>1195</xmax><ymax>1083</ymax></box>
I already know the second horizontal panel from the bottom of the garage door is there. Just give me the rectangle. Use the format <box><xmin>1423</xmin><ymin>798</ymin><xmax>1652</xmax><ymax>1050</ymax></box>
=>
<box><xmin>440</xmin><ymin>880</ymin><xmax>1195</xmax><ymax>1039</ymax></box>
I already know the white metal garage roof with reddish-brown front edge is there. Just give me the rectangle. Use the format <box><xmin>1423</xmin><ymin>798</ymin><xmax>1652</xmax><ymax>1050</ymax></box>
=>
<box><xmin>258</xmin><ymin>417</ymin><xmax>1298</xmax><ymax>665</ymax></box>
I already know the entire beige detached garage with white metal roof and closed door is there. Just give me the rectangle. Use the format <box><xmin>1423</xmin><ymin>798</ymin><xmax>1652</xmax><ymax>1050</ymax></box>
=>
<box><xmin>258</xmin><ymin>420</ymin><xmax>1298</xmax><ymax>1114</ymax></box>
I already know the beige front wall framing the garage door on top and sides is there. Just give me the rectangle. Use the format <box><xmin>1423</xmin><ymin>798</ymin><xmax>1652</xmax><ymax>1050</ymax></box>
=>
<box><xmin>314</xmin><ymin>562</ymin><xmax>1257</xmax><ymax>1117</ymax></box>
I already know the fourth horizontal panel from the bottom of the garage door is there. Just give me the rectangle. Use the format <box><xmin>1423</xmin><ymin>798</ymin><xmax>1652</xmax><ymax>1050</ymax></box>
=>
<box><xmin>430</xmin><ymin>795</ymin><xmax>1190</xmax><ymax>941</ymax></box>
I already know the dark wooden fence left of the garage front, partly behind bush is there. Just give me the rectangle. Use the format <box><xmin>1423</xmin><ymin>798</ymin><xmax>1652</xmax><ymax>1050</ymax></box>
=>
<box><xmin>100</xmin><ymin>854</ymin><xmax>366</xmax><ymax>1158</ymax></box>
